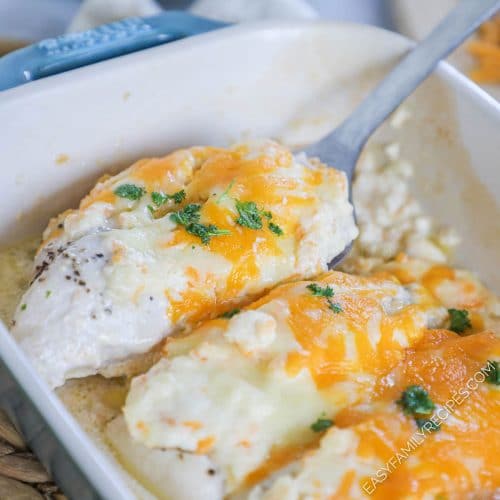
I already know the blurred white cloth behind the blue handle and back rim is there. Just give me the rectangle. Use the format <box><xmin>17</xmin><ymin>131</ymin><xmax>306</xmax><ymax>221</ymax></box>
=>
<box><xmin>68</xmin><ymin>0</ymin><xmax>317</xmax><ymax>32</ymax></box>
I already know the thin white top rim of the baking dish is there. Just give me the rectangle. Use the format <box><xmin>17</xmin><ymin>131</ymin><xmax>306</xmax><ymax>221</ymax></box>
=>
<box><xmin>0</xmin><ymin>20</ymin><xmax>500</xmax><ymax>499</ymax></box>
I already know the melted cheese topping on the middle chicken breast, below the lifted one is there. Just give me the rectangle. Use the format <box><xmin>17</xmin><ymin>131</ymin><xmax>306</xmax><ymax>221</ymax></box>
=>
<box><xmin>124</xmin><ymin>272</ymin><xmax>446</xmax><ymax>492</ymax></box>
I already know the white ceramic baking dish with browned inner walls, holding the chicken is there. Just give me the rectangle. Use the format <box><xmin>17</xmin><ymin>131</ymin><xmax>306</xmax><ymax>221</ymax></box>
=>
<box><xmin>0</xmin><ymin>13</ymin><xmax>500</xmax><ymax>499</ymax></box>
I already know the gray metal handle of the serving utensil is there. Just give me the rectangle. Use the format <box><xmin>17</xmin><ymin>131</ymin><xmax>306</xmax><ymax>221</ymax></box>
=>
<box><xmin>314</xmin><ymin>0</ymin><xmax>500</xmax><ymax>172</ymax></box>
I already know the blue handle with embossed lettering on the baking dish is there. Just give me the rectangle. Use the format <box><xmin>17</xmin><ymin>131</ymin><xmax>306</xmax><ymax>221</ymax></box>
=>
<box><xmin>0</xmin><ymin>11</ymin><xmax>227</xmax><ymax>90</ymax></box>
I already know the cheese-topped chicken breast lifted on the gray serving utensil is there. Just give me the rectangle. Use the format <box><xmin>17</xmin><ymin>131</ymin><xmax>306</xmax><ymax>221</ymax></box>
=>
<box><xmin>12</xmin><ymin>142</ymin><xmax>357</xmax><ymax>387</ymax></box>
